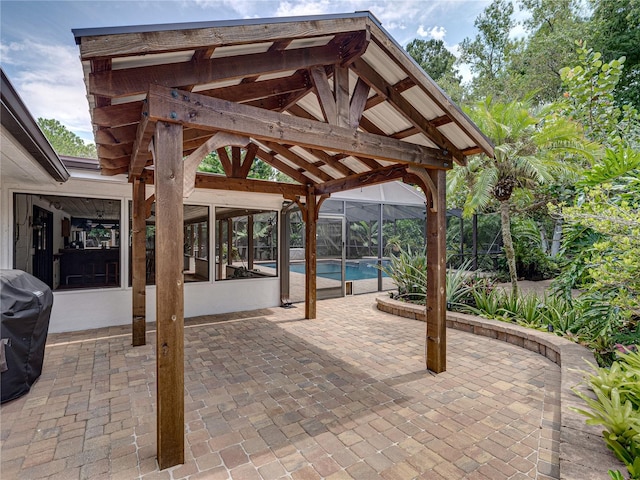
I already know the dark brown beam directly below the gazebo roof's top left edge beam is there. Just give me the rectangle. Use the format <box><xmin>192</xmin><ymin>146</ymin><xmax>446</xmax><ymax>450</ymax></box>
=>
<box><xmin>89</xmin><ymin>44</ymin><xmax>348</xmax><ymax>98</ymax></box>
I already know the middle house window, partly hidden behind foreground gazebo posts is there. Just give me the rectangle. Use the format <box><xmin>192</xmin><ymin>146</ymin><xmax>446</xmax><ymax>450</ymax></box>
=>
<box><xmin>129</xmin><ymin>202</ymin><xmax>209</xmax><ymax>285</ymax></box>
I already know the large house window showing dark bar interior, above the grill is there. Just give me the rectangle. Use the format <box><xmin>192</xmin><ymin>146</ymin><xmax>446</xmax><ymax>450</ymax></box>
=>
<box><xmin>13</xmin><ymin>194</ymin><xmax>120</xmax><ymax>290</ymax></box>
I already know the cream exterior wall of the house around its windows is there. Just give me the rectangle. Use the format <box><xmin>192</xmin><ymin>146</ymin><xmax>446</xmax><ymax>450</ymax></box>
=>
<box><xmin>0</xmin><ymin>171</ymin><xmax>282</xmax><ymax>333</ymax></box>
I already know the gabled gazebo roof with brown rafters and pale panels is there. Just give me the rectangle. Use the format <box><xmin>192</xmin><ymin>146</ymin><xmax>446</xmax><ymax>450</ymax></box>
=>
<box><xmin>73</xmin><ymin>12</ymin><xmax>493</xmax><ymax>194</ymax></box>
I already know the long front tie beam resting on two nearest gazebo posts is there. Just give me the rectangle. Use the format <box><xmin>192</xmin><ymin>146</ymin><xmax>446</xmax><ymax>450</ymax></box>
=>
<box><xmin>148</xmin><ymin>85</ymin><xmax>452</xmax><ymax>168</ymax></box>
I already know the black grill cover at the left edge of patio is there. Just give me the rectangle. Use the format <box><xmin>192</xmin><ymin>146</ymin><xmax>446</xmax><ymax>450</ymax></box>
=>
<box><xmin>0</xmin><ymin>270</ymin><xmax>53</xmax><ymax>403</ymax></box>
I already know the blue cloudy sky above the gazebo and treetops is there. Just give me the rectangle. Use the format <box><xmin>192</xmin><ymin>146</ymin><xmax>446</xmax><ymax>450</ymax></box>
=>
<box><xmin>0</xmin><ymin>0</ymin><xmax>518</xmax><ymax>142</ymax></box>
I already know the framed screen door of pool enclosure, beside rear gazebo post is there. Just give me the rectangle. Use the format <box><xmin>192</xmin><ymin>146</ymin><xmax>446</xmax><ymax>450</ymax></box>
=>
<box><xmin>316</xmin><ymin>215</ymin><xmax>345</xmax><ymax>300</ymax></box>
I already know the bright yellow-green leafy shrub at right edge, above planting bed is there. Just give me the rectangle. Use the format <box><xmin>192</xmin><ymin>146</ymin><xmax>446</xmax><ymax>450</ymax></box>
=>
<box><xmin>561</xmin><ymin>147</ymin><xmax>640</xmax><ymax>317</ymax></box>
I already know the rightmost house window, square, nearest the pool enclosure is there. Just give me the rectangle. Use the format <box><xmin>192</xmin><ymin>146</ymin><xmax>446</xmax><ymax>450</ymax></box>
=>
<box><xmin>216</xmin><ymin>207</ymin><xmax>278</xmax><ymax>280</ymax></box>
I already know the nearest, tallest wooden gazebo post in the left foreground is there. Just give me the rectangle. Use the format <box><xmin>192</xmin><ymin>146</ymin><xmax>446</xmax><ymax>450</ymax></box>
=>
<box><xmin>155</xmin><ymin>122</ymin><xmax>184</xmax><ymax>470</ymax></box>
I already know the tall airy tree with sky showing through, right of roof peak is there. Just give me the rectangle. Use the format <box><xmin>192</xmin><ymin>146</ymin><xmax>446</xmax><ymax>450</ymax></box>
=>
<box><xmin>460</xmin><ymin>0</ymin><xmax>515</xmax><ymax>98</ymax></box>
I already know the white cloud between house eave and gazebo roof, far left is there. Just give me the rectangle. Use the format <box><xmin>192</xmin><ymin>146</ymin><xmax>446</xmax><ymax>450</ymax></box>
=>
<box><xmin>2</xmin><ymin>40</ymin><xmax>93</xmax><ymax>141</ymax></box>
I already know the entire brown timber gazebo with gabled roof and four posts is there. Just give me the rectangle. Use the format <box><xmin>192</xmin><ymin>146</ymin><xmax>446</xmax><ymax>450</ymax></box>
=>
<box><xmin>74</xmin><ymin>12</ymin><xmax>493</xmax><ymax>468</ymax></box>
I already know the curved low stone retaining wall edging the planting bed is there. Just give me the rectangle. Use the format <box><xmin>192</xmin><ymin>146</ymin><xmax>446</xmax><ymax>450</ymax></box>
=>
<box><xmin>376</xmin><ymin>298</ymin><xmax>627</xmax><ymax>480</ymax></box>
